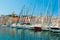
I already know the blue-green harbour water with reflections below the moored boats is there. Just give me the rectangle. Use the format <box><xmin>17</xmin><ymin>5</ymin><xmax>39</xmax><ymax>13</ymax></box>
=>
<box><xmin>0</xmin><ymin>28</ymin><xmax>60</xmax><ymax>40</ymax></box>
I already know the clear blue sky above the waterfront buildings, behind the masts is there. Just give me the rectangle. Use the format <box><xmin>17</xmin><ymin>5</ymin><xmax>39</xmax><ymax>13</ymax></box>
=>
<box><xmin>0</xmin><ymin>0</ymin><xmax>58</xmax><ymax>16</ymax></box>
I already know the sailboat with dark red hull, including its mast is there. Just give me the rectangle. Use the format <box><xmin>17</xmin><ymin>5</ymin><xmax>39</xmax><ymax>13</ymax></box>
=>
<box><xmin>30</xmin><ymin>1</ymin><xmax>42</xmax><ymax>32</ymax></box>
